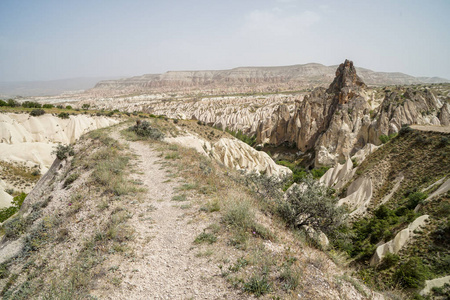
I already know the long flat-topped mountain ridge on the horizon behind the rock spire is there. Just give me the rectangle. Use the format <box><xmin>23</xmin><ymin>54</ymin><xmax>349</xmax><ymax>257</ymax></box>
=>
<box><xmin>91</xmin><ymin>63</ymin><xmax>450</xmax><ymax>92</ymax></box>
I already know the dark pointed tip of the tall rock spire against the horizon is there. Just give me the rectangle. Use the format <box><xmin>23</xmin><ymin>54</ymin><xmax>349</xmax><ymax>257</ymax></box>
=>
<box><xmin>327</xmin><ymin>59</ymin><xmax>366</xmax><ymax>104</ymax></box>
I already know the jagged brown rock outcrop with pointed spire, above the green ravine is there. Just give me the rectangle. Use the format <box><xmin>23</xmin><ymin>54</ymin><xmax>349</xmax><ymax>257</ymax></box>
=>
<box><xmin>257</xmin><ymin>60</ymin><xmax>450</xmax><ymax>166</ymax></box>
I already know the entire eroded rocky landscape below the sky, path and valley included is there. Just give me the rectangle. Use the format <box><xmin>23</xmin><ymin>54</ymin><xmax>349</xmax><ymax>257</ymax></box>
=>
<box><xmin>0</xmin><ymin>60</ymin><xmax>450</xmax><ymax>299</ymax></box>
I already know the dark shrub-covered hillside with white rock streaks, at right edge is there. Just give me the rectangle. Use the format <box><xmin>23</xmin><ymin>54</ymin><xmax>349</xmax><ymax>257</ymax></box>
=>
<box><xmin>324</xmin><ymin>127</ymin><xmax>450</xmax><ymax>299</ymax></box>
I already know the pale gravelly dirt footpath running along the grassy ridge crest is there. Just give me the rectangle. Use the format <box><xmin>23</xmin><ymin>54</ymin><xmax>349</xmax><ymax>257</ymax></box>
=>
<box><xmin>99</xmin><ymin>131</ymin><xmax>247</xmax><ymax>299</ymax></box>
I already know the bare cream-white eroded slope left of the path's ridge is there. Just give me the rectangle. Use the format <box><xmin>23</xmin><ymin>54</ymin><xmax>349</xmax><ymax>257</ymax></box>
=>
<box><xmin>0</xmin><ymin>113</ymin><xmax>118</xmax><ymax>208</ymax></box>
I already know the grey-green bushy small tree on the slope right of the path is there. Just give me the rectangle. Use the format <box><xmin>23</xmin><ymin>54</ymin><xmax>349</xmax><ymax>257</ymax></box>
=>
<box><xmin>279</xmin><ymin>176</ymin><xmax>345</xmax><ymax>233</ymax></box>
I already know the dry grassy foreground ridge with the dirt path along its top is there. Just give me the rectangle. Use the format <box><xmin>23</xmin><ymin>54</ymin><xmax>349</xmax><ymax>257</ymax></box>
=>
<box><xmin>0</xmin><ymin>119</ymin><xmax>382</xmax><ymax>299</ymax></box>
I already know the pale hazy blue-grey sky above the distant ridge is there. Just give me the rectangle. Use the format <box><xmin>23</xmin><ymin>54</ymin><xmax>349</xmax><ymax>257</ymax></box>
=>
<box><xmin>0</xmin><ymin>0</ymin><xmax>450</xmax><ymax>81</ymax></box>
